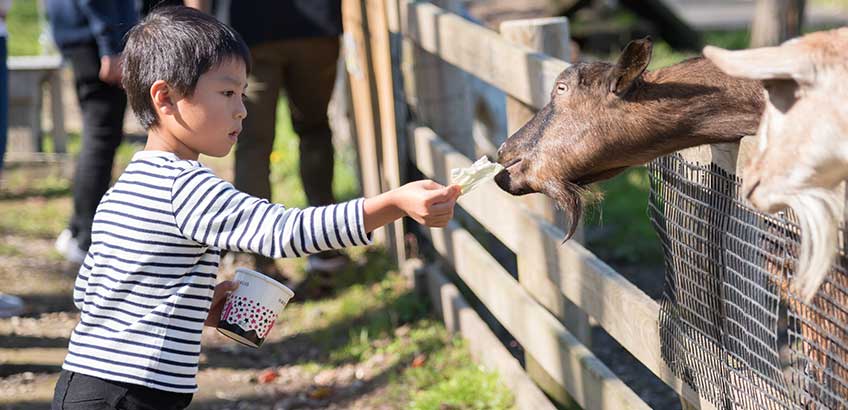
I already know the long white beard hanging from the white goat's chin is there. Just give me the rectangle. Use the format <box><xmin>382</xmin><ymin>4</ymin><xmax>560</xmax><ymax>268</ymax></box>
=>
<box><xmin>785</xmin><ymin>188</ymin><xmax>840</xmax><ymax>302</ymax></box>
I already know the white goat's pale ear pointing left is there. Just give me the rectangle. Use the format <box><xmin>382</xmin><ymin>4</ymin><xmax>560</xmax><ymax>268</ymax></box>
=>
<box><xmin>704</xmin><ymin>43</ymin><xmax>813</xmax><ymax>84</ymax></box>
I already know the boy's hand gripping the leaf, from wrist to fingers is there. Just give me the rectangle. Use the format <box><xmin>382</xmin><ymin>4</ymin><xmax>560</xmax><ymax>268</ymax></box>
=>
<box><xmin>397</xmin><ymin>180</ymin><xmax>462</xmax><ymax>228</ymax></box>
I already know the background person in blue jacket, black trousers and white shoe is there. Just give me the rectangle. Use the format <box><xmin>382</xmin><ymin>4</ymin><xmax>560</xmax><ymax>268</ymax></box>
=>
<box><xmin>46</xmin><ymin>0</ymin><xmax>138</xmax><ymax>264</ymax></box>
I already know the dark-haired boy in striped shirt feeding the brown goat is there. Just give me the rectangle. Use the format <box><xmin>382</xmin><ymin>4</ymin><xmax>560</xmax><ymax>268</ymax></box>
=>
<box><xmin>53</xmin><ymin>7</ymin><xmax>459</xmax><ymax>410</ymax></box>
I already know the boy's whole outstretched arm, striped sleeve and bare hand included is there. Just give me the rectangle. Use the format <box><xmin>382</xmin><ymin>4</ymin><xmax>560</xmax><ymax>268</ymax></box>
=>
<box><xmin>171</xmin><ymin>168</ymin><xmax>460</xmax><ymax>258</ymax></box>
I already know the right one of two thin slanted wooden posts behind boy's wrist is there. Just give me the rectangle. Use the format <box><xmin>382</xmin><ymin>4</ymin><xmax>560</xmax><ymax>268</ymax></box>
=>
<box><xmin>365</xmin><ymin>0</ymin><xmax>406</xmax><ymax>266</ymax></box>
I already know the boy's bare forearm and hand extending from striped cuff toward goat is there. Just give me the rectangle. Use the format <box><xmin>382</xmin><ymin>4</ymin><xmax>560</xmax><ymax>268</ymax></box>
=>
<box><xmin>363</xmin><ymin>180</ymin><xmax>462</xmax><ymax>232</ymax></box>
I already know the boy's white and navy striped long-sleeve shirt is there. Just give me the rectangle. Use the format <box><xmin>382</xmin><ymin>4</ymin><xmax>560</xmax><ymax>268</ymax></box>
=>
<box><xmin>62</xmin><ymin>151</ymin><xmax>371</xmax><ymax>393</ymax></box>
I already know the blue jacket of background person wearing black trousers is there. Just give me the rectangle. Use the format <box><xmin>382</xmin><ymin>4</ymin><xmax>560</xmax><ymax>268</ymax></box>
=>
<box><xmin>47</xmin><ymin>0</ymin><xmax>138</xmax><ymax>57</ymax></box>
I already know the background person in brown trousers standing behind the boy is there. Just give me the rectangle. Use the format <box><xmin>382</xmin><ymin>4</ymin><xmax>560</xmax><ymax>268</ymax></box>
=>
<box><xmin>190</xmin><ymin>0</ymin><xmax>349</xmax><ymax>294</ymax></box>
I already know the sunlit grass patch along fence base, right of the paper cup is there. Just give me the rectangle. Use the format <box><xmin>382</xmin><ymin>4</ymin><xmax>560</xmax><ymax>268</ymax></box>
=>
<box><xmin>283</xmin><ymin>270</ymin><xmax>513</xmax><ymax>410</ymax></box>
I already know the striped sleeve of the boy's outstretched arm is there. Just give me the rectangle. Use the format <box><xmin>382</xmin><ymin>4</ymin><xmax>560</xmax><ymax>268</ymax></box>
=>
<box><xmin>171</xmin><ymin>167</ymin><xmax>372</xmax><ymax>258</ymax></box>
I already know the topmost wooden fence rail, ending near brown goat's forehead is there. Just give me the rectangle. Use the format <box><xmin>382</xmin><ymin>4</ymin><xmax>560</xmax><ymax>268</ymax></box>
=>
<box><xmin>389</xmin><ymin>0</ymin><xmax>569</xmax><ymax>109</ymax></box>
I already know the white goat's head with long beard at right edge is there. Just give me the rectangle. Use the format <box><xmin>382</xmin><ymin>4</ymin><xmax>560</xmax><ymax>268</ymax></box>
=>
<box><xmin>704</xmin><ymin>28</ymin><xmax>848</xmax><ymax>301</ymax></box>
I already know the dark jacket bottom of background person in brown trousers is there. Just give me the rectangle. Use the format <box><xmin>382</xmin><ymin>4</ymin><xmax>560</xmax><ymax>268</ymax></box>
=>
<box><xmin>229</xmin><ymin>0</ymin><xmax>342</xmax><ymax>46</ymax></box>
